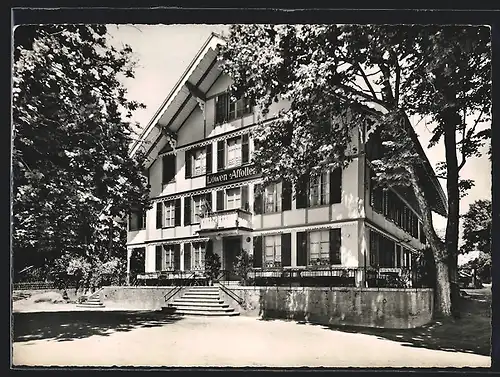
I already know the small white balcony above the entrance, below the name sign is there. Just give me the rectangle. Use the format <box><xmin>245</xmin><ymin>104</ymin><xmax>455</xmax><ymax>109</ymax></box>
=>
<box><xmin>198</xmin><ymin>208</ymin><xmax>252</xmax><ymax>235</ymax></box>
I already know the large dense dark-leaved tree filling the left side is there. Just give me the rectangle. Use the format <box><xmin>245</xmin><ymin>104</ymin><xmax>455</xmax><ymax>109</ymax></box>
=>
<box><xmin>12</xmin><ymin>25</ymin><xmax>149</xmax><ymax>285</ymax></box>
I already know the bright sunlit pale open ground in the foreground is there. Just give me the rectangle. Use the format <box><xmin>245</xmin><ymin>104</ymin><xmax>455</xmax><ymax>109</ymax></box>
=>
<box><xmin>13</xmin><ymin>312</ymin><xmax>490</xmax><ymax>367</ymax></box>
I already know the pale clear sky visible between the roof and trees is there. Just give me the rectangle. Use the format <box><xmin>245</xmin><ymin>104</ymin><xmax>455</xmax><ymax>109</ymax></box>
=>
<box><xmin>108</xmin><ymin>24</ymin><xmax>491</xmax><ymax>258</ymax></box>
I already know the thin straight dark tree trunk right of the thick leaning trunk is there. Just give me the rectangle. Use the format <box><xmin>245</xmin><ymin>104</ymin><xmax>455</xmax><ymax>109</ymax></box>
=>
<box><xmin>441</xmin><ymin>108</ymin><xmax>460</xmax><ymax>317</ymax></box>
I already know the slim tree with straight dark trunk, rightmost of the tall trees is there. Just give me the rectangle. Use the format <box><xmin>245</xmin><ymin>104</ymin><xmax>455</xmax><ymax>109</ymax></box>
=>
<box><xmin>402</xmin><ymin>26</ymin><xmax>491</xmax><ymax>314</ymax></box>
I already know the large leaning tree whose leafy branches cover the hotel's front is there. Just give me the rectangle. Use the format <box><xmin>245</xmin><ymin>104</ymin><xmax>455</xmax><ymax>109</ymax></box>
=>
<box><xmin>221</xmin><ymin>25</ymin><xmax>488</xmax><ymax>316</ymax></box>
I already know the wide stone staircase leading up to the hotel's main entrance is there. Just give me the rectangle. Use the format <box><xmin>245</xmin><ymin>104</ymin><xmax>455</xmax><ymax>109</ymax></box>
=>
<box><xmin>162</xmin><ymin>287</ymin><xmax>240</xmax><ymax>316</ymax></box>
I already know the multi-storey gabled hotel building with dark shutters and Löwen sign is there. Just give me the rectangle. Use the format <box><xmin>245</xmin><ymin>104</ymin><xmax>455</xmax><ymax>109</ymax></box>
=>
<box><xmin>127</xmin><ymin>34</ymin><xmax>446</xmax><ymax>286</ymax></box>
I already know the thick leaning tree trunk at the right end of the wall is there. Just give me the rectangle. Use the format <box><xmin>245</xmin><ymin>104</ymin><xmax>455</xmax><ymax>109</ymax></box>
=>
<box><xmin>408</xmin><ymin>166</ymin><xmax>451</xmax><ymax>318</ymax></box>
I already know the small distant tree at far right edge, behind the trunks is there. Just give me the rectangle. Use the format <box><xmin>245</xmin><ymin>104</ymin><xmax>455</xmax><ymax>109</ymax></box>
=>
<box><xmin>460</xmin><ymin>200</ymin><xmax>492</xmax><ymax>281</ymax></box>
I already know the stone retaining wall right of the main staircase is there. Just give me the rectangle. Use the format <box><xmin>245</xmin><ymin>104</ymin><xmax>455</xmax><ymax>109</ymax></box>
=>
<box><xmin>219</xmin><ymin>287</ymin><xmax>434</xmax><ymax>328</ymax></box>
